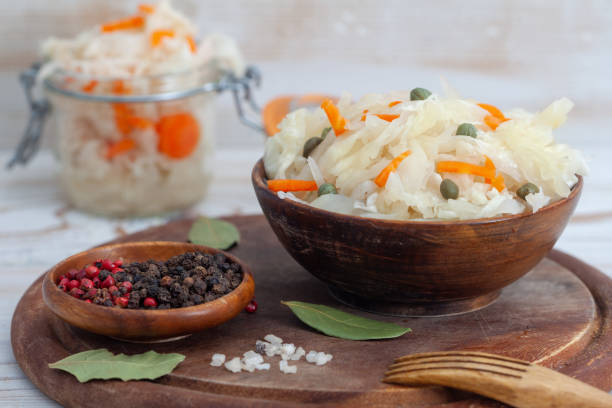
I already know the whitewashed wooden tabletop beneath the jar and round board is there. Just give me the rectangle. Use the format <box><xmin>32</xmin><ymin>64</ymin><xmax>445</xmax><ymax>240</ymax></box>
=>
<box><xmin>0</xmin><ymin>140</ymin><xmax>612</xmax><ymax>407</ymax></box>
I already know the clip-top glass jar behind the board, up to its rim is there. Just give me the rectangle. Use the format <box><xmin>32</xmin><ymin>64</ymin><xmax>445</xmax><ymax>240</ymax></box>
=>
<box><xmin>11</xmin><ymin>65</ymin><xmax>259</xmax><ymax>216</ymax></box>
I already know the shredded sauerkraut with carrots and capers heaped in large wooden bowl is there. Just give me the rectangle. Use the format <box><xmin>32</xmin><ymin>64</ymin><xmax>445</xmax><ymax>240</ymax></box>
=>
<box><xmin>264</xmin><ymin>88</ymin><xmax>587</xmax><ymax>220</ymax></box>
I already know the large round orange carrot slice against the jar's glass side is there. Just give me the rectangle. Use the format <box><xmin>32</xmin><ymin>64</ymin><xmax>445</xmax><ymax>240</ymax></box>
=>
<box><xmin>155</xmin><ymin>113</ymin><xmax>200</xmax><ymax>159</ymax></box>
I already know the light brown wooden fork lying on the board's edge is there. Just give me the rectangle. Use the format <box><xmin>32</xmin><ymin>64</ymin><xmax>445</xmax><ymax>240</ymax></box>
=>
<box><xmin>383</xmin><ymin>351</ymin><xmax>612</xmax><ymax>408</ymax></box>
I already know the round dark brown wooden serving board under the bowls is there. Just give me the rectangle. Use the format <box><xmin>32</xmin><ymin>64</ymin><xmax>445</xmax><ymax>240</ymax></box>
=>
<box><xmin>11</xmin><ymin>216</ymin><xmax>612</xmax><ymax>408</ymax></box>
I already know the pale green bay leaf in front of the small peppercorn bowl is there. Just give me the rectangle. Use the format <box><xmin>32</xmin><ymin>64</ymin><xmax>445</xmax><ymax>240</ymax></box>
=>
<box><xmin>49</xmin><ymin>349</ymin><xmax>185</xmax><ymax>383</ymax></box>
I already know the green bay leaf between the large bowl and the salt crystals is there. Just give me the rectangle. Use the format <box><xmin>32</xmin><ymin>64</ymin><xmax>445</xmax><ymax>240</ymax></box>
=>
<box><xmin>281</xmin><ymin>301</ymin><xmax>411</xmax><ymax>340</ymax></box>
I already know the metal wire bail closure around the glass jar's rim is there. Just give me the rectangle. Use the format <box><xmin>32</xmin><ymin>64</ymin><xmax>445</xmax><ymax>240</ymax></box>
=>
<box><xmin>6</xmin><ymin>63</ymin><xmax>263</xmax><ymax>169</ymax></box>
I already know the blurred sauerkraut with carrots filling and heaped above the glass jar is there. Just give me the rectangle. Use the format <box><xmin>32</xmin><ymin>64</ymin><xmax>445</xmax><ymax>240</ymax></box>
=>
<box><xmin>39</xmin><ymin>2</ymin><xmax>245</xmax><ymax>216</ymax></box>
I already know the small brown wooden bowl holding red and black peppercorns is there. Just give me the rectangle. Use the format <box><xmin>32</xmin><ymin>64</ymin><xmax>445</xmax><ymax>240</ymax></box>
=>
<box><xmin>43</xmin><ymin>241</ymin><xmax>255</xmax><ymax>342</ymax></box>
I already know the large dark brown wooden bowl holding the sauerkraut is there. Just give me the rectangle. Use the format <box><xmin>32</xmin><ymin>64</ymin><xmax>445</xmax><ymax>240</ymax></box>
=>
<box><xmin>252</xmin><ymin>160</ymin><xmax>582</xmax><ymax>316</ymax></box>
